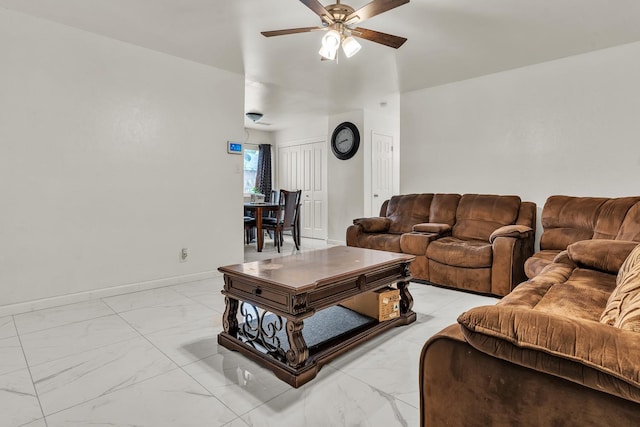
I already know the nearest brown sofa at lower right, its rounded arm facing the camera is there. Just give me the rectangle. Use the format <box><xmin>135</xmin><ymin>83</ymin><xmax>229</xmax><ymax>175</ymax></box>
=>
<box><xmin>419</xmin><ymin>239</ymin><xmax>640</xmax><ymax>427</ymax></box>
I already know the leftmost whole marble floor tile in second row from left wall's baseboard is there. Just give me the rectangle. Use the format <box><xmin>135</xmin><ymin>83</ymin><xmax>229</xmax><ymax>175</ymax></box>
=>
<box><xmin>21</xmin><ymin>314</ymin><xmax>139</xmax><ymax>366</ymax></box>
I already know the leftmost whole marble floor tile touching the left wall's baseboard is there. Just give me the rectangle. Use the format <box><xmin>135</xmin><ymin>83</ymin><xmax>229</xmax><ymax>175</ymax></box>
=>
<box><xmin>14</xmin><ymin>300</ymin><xmax>114</xmax><ymax>335</ymax></box>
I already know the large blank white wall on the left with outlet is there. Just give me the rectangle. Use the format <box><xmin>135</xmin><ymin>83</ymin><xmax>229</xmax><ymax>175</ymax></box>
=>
<box><xmin>0</xmin><ymin>9</ymin><xmax>244</xmax><ymax>309</ymax></box>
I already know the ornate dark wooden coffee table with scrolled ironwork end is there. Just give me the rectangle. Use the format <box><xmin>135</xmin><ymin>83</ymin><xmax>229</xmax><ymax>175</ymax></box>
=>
<box><xmin>218</xmin><ymin>246</ymin><xmax>416</xmax><ymax>387</ymax></box>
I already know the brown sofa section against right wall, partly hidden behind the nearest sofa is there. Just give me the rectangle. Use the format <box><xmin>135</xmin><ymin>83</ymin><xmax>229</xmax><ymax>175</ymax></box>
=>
<box><xmin>525</xmin><ymin>196</ymin><xmax>640</xmax><ymax>278</ymax></box>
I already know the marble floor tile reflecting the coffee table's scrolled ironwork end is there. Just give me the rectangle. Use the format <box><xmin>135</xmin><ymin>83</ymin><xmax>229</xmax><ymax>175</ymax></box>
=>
<box><xmin>183</xmin><ymin>348</ymin><xmax>291</xmax><ymax>414</ymax></box>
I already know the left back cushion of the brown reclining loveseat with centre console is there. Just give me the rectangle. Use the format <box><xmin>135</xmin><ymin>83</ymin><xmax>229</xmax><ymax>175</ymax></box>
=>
<box><xmin>386</xmin><ymin>194</ymin><xmax>433</xmax><ymax>234</ymax></box>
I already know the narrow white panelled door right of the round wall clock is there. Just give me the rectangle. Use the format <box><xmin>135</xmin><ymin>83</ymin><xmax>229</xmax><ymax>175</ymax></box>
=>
<box><xmin>371</xmin><ymin>132</ymin><xmax>393</xmax><ymax>215</ymax></box>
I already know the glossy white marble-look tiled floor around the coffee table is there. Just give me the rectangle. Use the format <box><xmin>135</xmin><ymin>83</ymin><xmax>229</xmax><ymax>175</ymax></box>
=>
<box><xmin>0</xmin><ymin>244</ymin><xmax>498</xmax><ymax>427</ymax></box>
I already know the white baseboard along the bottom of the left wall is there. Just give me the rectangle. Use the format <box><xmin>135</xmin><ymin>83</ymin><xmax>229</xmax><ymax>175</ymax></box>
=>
<box><xmin>0</xmin><ymin>270</ymin><xmax>222</xmax><ymax>317</ymax></box>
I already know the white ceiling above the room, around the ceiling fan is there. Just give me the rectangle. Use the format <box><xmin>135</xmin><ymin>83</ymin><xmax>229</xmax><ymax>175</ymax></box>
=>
<box><xmin>0</xmin><ymin>0</ymin><xmax>640</xmax><ymax>130</ymax></box>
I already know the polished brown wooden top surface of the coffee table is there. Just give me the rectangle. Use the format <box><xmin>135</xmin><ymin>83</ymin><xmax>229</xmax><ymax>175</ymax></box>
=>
<box><xmin>218</xmin><ymin>246</ymin><xmax>415</xmax><ymax>292</ymax></box>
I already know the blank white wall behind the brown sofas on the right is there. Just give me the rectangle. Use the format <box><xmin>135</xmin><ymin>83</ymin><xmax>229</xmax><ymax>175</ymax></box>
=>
<box><xmin>401</xmin><ymin>39</ymin><xmax>640</xmax><ymax>217</ymax></box>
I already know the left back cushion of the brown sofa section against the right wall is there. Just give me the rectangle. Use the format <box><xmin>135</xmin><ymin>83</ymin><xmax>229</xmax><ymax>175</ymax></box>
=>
<box><xmin>540</xmin><ymin>196</ymin><xmax>608</xmax><ymax>250</ymax></box>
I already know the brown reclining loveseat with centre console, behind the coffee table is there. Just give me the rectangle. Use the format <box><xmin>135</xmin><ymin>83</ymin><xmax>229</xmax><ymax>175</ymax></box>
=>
<box><xmin>347</xmin><ymin>193</ymin><xmax>536</xmax><ymax>296</ymax></box>
